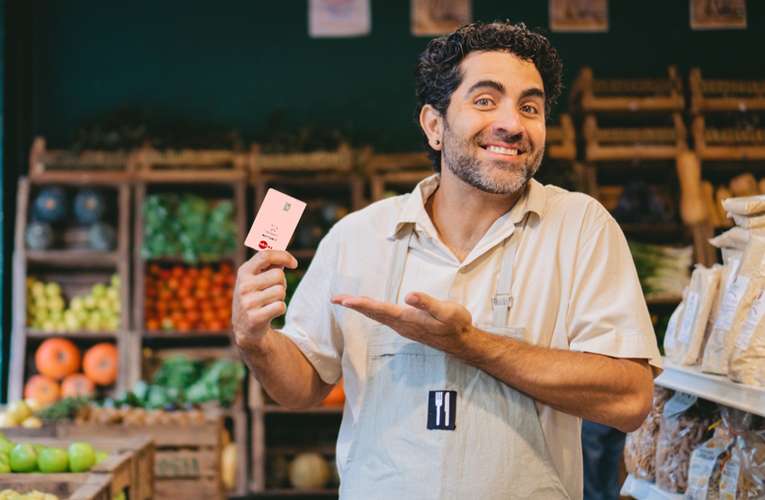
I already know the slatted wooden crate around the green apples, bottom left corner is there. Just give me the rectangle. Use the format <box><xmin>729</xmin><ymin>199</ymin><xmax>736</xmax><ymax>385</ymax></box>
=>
<box><xmin>0</xmin><ymin>434</ymin><xmax>154</xmax><ymax>500</ymax></box>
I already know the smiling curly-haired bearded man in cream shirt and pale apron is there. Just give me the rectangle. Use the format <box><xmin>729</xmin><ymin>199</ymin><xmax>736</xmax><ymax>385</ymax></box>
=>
<box><xmin>233</xmin><ymin>23</ymin><xmax>661</xmax><ymax>500</ymax></box>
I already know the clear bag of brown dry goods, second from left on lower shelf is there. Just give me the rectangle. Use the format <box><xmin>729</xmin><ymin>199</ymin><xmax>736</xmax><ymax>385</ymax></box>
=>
<box><xmin>656</xmin><ymin>392</ymin><xmax>717</xmax><ymax>493</ymax></box>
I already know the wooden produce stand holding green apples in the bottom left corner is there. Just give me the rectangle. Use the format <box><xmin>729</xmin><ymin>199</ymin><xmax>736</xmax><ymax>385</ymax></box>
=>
<box><xmin>0</xmin><ymin>427</ymin><xmax>155</xmax><ymax>500</ymax></box>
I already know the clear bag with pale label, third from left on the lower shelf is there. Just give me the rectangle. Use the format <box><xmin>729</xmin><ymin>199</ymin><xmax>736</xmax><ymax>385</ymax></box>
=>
<box><xmin>685</xmin><ymin>414</ymin><xmax>734</xmax><ymax>500</ymax></box>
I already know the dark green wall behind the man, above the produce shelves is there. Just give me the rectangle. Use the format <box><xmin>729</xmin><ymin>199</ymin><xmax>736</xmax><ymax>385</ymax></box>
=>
<box><xmin>0</xmin><ymin>0</ymin><xmax>765</xmax><ymax>399</ymax></box>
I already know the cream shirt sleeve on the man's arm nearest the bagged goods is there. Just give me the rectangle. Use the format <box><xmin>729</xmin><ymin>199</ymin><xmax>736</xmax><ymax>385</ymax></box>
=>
<box><xmin>567</xmin><ymin>215</ymin><xmax>663</xmax><ymax>376</ymax></box>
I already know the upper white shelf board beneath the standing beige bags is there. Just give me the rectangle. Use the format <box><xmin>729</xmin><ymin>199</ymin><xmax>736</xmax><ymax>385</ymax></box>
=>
<box><xmin>655</xmin><ymin>358</ymin><xmax>765</xmax><ymax>415</ymax></box>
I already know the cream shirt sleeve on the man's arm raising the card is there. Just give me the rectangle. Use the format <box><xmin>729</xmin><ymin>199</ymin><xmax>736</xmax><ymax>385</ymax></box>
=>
<box><xmin>281</xmin><ymin>238</ymin><xmax>343</xmax><ymax>384</ymax></box>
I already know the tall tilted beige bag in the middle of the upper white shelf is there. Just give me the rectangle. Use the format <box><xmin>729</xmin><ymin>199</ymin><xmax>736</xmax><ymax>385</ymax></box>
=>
<box><xmin>702</xmin><ymin>233</ymin><xmax>765</xmax><ymax>375</ymax></box>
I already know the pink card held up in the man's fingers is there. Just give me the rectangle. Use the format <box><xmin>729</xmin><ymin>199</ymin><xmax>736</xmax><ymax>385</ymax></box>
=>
<box><xmin>244</xmin><ymin>189</ymin><xmax>305</xmax><ymax>250</ymax></box>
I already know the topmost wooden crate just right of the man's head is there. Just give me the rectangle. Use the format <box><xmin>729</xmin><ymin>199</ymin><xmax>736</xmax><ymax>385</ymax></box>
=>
<box><xmin>570</xmin><ymin>66</ymin><xmax>685</xmax><ymax>113</ymax></box>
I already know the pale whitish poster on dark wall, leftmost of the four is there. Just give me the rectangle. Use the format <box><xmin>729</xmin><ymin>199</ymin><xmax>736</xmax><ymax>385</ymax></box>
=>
<box><xmin>308</xmin><ymin>0</ymin><xmax>372</xmax><ymax>38</ymax></box>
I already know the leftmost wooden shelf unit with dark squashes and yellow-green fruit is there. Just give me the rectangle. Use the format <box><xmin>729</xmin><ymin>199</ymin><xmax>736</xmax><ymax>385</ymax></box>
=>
<box><xmin>8</xmin><ymin>172</ymin><xmax>132</xmax><ymax>401</ymax></box>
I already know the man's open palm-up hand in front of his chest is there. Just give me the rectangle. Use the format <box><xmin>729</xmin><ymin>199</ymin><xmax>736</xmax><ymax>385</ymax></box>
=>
<box><xmin>330</xmin><ymin>292</ymin><xmax>473</xmax><ymax>353</ymax></box>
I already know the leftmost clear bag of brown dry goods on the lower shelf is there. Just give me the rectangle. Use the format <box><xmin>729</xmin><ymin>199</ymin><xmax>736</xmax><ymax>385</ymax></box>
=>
<box><xmin>624</xmin><ymin>385</ymin><xmax>675</xmax><ymax>481</ymax></box>
